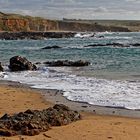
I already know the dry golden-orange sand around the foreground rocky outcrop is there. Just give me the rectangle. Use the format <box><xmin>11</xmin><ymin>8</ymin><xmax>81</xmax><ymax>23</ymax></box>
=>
<box><xmin>0</xmin><ymin>83</ymin><xmax>140</xmax><ymax>140</ymax></box>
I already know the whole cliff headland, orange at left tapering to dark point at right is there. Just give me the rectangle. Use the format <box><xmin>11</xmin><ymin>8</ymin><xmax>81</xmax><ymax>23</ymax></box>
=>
<box><xmin>0</xmin><ymin>12</ymin><xmax>130</xmax><ymax>32</ymax></box>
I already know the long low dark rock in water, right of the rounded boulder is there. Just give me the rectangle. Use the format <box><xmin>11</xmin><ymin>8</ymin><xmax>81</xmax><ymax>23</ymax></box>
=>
<box><xmin>44</xmin><ymin>60</ymin><xmax>90</xmax><ymax>67</ymax></box>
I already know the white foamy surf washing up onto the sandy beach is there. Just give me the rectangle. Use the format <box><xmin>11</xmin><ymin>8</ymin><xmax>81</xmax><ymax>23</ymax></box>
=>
<box><xmin>0</xmin><ymin>67</ymin><xmax>140</xmax><ymax>109</ymax></box>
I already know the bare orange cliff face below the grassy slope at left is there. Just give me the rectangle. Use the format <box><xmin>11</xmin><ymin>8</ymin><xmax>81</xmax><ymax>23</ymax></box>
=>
<box><xmin>0</xmin><ymin>18</ymin><xmax>57</xmax><ymax>32</ymax></box>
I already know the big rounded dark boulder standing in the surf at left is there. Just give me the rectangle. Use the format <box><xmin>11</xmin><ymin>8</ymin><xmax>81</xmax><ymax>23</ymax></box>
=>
<box><xmin>9</xmin><ymin>56</ymin><xmax>37</xmax><ymax>71</ymax></box>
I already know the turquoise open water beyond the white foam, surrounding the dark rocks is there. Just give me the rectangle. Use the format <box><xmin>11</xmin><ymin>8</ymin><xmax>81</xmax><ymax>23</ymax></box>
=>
<box><xmin>0</xmin><ymin>33</ymin><xmax>140</xmax><ymax>79</ymax></box>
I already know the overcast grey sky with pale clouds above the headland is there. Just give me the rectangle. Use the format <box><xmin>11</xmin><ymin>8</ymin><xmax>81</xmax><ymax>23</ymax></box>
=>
<box><xmin>0</xmin><ymin>0</ymin><xmax>140</xmax><ymax>20</ymax></box>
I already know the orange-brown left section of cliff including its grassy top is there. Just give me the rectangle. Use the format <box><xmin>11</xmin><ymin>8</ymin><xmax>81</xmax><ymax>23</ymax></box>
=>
<box><xmin>0</xmin><ymin>13</ymin><xmax>57</xmax><ymax>31</ymax></box>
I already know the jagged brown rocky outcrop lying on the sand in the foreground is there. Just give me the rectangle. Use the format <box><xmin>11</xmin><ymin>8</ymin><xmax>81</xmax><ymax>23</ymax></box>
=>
<box><xmin>0</xmin><ymin>104</ymin><xmax>81</xmax><ymax>136</ymax></box>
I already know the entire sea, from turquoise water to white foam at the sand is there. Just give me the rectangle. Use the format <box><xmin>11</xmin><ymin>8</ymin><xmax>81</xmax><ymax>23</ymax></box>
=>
<box><xmin>0</xmin><ymin>32</ymin><xmax>140</xmax><ymax>109</ymax></box>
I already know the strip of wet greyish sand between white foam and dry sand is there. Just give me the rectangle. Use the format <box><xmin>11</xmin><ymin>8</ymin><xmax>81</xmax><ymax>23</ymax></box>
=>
<box><xmin>0</xmin><ymin>80</ymin><xmax>140</xmax><ymax>119</ymax></box>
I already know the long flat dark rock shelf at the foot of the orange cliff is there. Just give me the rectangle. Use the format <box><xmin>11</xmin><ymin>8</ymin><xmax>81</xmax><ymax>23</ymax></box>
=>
<box><xmin>0</xmin><ymin>32</ymin><xmax>76</xmax><ymax>40</ymax></box>
